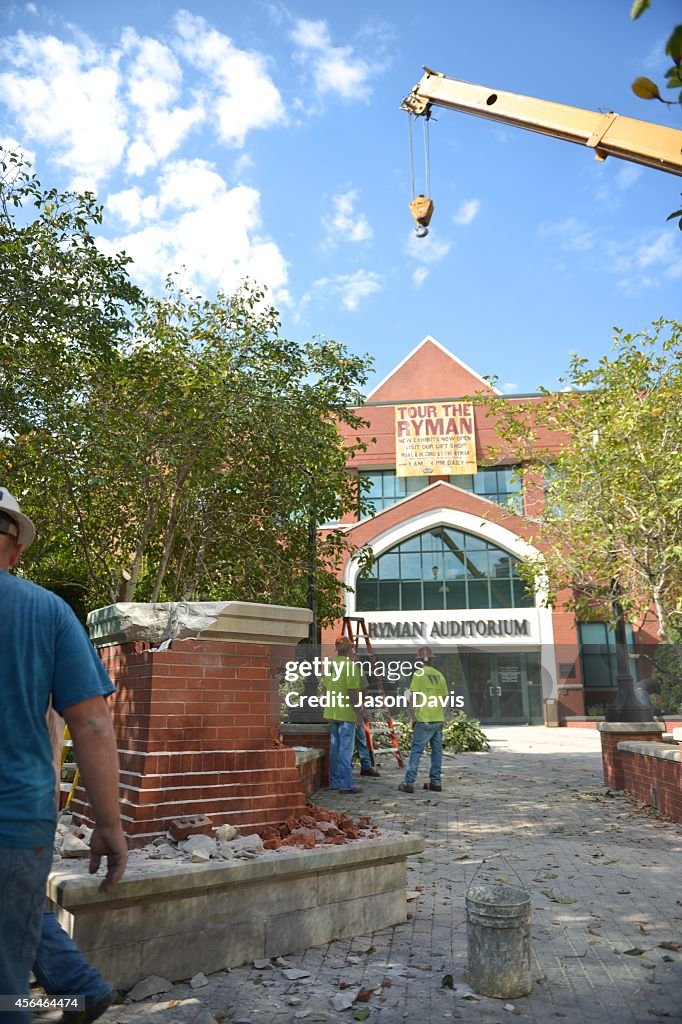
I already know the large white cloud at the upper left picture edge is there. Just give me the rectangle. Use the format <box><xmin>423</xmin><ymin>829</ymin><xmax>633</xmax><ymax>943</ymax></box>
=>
<box><xmin>0</xmin><ymin>32</ymin><xmax>127</xmax><ymax>189</ymax></box>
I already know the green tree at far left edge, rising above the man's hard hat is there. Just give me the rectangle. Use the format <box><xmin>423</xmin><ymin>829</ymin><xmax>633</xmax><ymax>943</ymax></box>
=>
<box><xmin>0</xmin><ymin>150</ymin><xmax>140</xmax><ymax>429</ymax></box>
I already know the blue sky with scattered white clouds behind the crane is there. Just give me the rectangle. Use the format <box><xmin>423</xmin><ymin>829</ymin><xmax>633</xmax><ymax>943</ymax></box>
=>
<box><xmin>0</xmin><ymin>0</ymin><xmax>682</xmax><ymax>393</ymax></box>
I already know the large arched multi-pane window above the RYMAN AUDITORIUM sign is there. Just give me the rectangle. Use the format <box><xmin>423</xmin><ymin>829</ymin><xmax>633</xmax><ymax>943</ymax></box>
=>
<box><xmin>355</xmin><ymin>526</ymin><xmax>535</xmax><ymax>611</ymax></box>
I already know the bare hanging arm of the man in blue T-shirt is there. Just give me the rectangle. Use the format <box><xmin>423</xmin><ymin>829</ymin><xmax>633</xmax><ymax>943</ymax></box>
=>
<box><xmin>63</xmin><ymin>696</ymin><xmax>128</xmax><ymax>892</ymax></box>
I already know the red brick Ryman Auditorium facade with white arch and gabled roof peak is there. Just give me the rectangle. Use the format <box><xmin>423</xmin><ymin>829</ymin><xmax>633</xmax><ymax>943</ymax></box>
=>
<box><xmin>323</xmin><ymin>337</ymin><xmax>655</xmax><ymax>724</ymax></box>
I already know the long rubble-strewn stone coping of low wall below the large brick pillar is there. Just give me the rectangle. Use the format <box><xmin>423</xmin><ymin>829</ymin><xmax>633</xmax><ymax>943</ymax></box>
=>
<box><xmin>47</xmin><ymin>833</ymin><xmax>425</xmax><ymax>910</ymax></box>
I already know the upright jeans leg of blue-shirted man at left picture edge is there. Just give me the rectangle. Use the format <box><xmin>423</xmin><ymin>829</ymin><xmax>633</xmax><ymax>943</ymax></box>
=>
<box><xmin>0</xmin><ymin>843</ymin><xmax>52</xmax><ymax>1024</ymax></box>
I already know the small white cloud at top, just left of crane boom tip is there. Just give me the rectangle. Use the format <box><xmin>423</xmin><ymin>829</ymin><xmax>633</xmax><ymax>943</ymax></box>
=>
<box><xmin>291</xmin><ymin>18</ymin><xmax>376</xmax><ymax>102</ymax></box>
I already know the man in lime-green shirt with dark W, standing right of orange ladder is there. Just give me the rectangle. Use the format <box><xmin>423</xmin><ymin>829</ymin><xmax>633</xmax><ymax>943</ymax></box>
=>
<box><xmin>398</xmin><ymin>647</ymin><xmax>450</xmax><ymax>793</ymax></box>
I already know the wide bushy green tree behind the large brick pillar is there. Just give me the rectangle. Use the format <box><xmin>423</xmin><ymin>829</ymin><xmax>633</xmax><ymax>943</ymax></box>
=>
<box><xmin>4</xmin><ymin>282</ymin><xmax>368</xmax><ymax>618</ymax></box>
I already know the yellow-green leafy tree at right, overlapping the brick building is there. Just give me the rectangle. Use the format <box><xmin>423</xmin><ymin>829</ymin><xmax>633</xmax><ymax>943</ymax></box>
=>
<box><xmin>483</xmin><ymin>319</ymin><xmax>682</xmax><ymax>640</ymax></box>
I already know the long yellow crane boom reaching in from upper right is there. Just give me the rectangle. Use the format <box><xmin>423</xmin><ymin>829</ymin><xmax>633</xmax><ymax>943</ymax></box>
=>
<box><xmin>401</xmin><ymin>69</ymin><xmax>682</xmax><ymax>174</ymax></box>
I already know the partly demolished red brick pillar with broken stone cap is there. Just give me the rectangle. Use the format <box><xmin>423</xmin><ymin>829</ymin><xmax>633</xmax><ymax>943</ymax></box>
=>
<box><xmin>72</xmin><ymin>602</ymin><xmax>309</xmax><ymax>846</ymax></box>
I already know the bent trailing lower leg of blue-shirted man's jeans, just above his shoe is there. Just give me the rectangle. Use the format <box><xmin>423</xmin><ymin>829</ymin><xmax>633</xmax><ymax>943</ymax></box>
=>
<box><xmin>33</xmin><ymin>910</ymin><xmax>113</xmax><ymax>1008</ymax></box>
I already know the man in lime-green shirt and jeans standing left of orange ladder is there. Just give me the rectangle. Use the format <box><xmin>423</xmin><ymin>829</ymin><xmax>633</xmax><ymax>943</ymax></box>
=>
<box><xmin>322</xmin><ymin>637</ymin><xmax>363</xmax><ymax>794</ymax></box>
